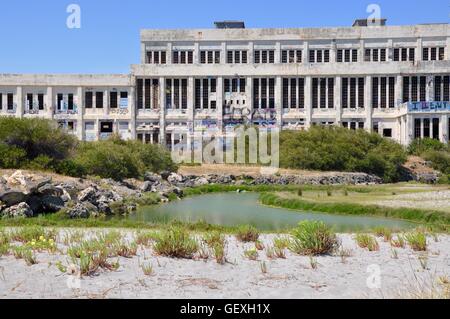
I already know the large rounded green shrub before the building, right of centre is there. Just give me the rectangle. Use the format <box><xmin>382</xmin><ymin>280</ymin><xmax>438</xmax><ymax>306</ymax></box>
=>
<box><xmin>280</xmin><ymin>126</ymin><xmax>406</xmax><ymax>182</ymax></box>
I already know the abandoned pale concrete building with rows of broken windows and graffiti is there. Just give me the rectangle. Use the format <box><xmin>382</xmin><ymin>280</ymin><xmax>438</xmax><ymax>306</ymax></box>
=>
<box><xmin>0</xmin><ymin>19</ymin><xmax>450</xmax><ymax>148</ymax></box>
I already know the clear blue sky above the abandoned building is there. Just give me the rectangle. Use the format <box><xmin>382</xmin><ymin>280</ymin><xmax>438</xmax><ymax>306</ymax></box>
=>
<box><xmin>0</xmin><ymin>0</ymin><xmax>450</xmax><ymax>73</ymax></box>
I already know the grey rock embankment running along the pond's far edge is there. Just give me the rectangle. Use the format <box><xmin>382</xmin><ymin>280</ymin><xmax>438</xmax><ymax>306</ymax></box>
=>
<box><xmin>0</xmin><ymin>170</ymin><xmax>382</xmax><ymax>218</ymax></box>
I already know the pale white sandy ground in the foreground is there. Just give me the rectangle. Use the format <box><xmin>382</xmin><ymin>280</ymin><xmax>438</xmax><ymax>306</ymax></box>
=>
<box><xmin>0</xmin><ymin>231</ymin><xmax>450</xmax><ymax>299</ymax></box>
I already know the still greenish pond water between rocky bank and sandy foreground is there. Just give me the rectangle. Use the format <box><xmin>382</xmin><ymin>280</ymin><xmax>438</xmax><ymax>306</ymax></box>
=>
<box><xmin>129</xmin><ymin>193</ymin><xmax>417</xmax><ymax>231</ymax></box>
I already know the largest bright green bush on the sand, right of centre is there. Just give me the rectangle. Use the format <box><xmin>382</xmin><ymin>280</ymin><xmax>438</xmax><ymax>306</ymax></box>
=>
<box><xmin>289</xmin><ymin>221</ymin><xmax>339</xmax><ymax>255</ymax></box>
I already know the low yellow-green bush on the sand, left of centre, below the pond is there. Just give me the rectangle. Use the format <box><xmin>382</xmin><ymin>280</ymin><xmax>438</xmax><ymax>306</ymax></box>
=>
<box><xmin>154</xmin><ymin>227</ymin><xmax>199</xmax><ymax>259</ymax></box>
